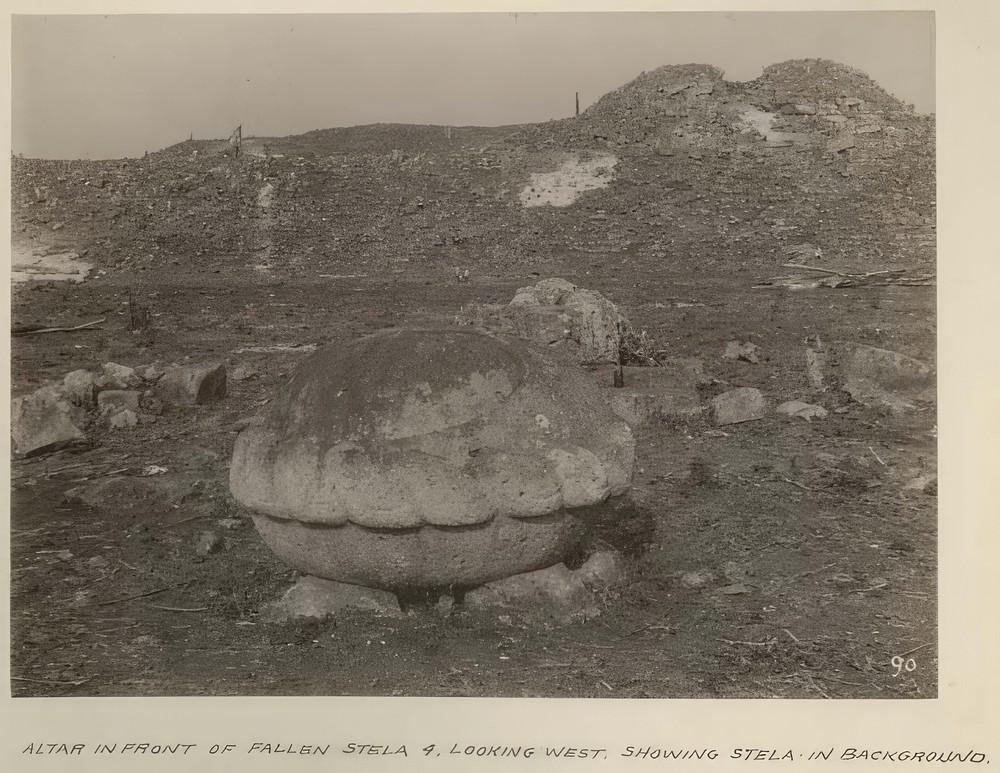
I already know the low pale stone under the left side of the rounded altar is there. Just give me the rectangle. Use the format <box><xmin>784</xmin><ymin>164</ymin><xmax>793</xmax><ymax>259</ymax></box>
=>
<box><xmin>260</xmin><ymin>575</ymin><xmax>402</xmax><ymax>623</ymax></box>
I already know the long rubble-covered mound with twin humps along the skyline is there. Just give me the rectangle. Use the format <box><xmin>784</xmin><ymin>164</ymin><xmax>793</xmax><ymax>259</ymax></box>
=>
<box><xmin>12</xmin><ymin>60</ymin><xmax>935</xmax><ymax>278</ymax></box>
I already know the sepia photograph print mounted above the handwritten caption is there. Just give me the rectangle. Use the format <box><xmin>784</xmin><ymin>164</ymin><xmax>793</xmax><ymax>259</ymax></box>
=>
<box><xmin>10</xmin><ymin>11</ymin><xmax>939</xmax><ymax>700</ymax></box>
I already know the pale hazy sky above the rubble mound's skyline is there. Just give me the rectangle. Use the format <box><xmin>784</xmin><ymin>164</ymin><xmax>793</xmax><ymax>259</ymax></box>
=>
<box><xmin>12</xmin><ymin>12</ymin><xmax>934</xmax><ymax>158</ymax></box>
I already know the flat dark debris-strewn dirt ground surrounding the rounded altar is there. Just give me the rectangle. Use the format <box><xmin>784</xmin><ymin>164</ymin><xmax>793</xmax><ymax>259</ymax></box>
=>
<box><xmin>12</xmin><ymin>270</ymin><xmax>936</xmax><ymax>698</ymax></box>
